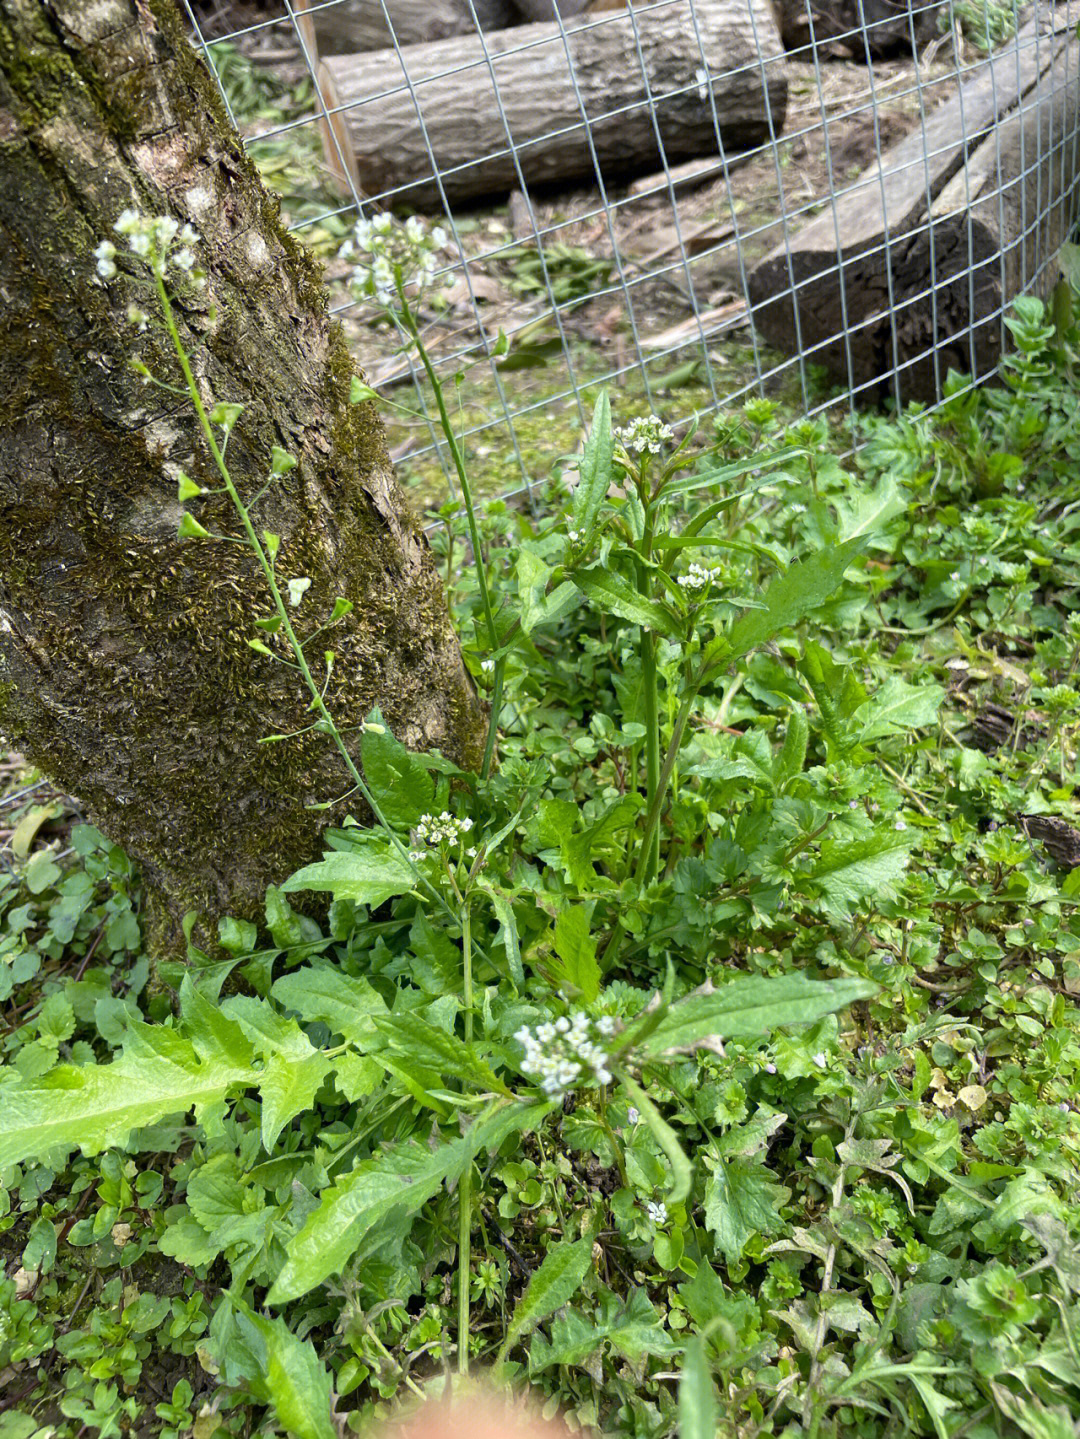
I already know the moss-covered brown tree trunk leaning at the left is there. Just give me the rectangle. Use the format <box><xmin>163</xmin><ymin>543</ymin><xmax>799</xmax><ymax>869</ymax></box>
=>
<box><xmin>0</xmin><ymin>0</ymin><xmax>483</xmax><ymax>948</ymax></box>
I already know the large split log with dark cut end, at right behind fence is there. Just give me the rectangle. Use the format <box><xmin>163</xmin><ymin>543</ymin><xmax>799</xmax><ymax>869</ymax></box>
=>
<box><xmin>748</xmin><ymin>17</ymin><xmax>1080</xmax><ymax>400</ymax></box>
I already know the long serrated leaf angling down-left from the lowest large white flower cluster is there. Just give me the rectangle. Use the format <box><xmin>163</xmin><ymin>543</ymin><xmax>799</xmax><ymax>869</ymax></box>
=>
<box><xmin>266</xmin><ymin>1104</ymin><xmax>551</xmax><ymax>1304</ymax></box>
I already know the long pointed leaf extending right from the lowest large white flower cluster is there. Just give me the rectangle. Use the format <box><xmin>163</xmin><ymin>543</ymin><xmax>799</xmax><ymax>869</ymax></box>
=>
<box><xmin>641</xmin><ymin>974</ymin><xmax>877</xmax><ymax>1055</ymax></box>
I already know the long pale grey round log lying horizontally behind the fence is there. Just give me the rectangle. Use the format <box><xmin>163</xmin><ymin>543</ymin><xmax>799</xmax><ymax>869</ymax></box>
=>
<box><xmin>319</xmin><ymin>0</ymin><xmax>787</xmax><ymax>209</ymax></box>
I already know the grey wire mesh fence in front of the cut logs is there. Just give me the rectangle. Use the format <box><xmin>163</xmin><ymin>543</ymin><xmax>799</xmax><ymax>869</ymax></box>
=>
<box><xmin>186</xmin><ymin>0</ymin><xmax>1080</xmax><ymax>501</ymax></box>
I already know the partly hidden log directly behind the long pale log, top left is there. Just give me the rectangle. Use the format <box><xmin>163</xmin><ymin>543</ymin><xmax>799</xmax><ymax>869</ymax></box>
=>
<box><xmin>296</xmin><ymin>0</ymin><xmax>513</xmax><ymax>55</ymax></box>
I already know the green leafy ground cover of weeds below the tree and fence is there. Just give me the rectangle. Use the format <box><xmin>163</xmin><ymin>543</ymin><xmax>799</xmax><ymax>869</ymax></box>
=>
<box><xmin>0</xmin><ymin>286</ymin><xmax>1080</xmax><ymax>1439</ymax></box>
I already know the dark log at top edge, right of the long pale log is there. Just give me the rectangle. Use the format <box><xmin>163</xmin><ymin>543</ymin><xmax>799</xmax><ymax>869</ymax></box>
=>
<box><xmin>774</xmin><ymin>0</ymin><xmax>938</xmax><ymax>60</ymax></box>
